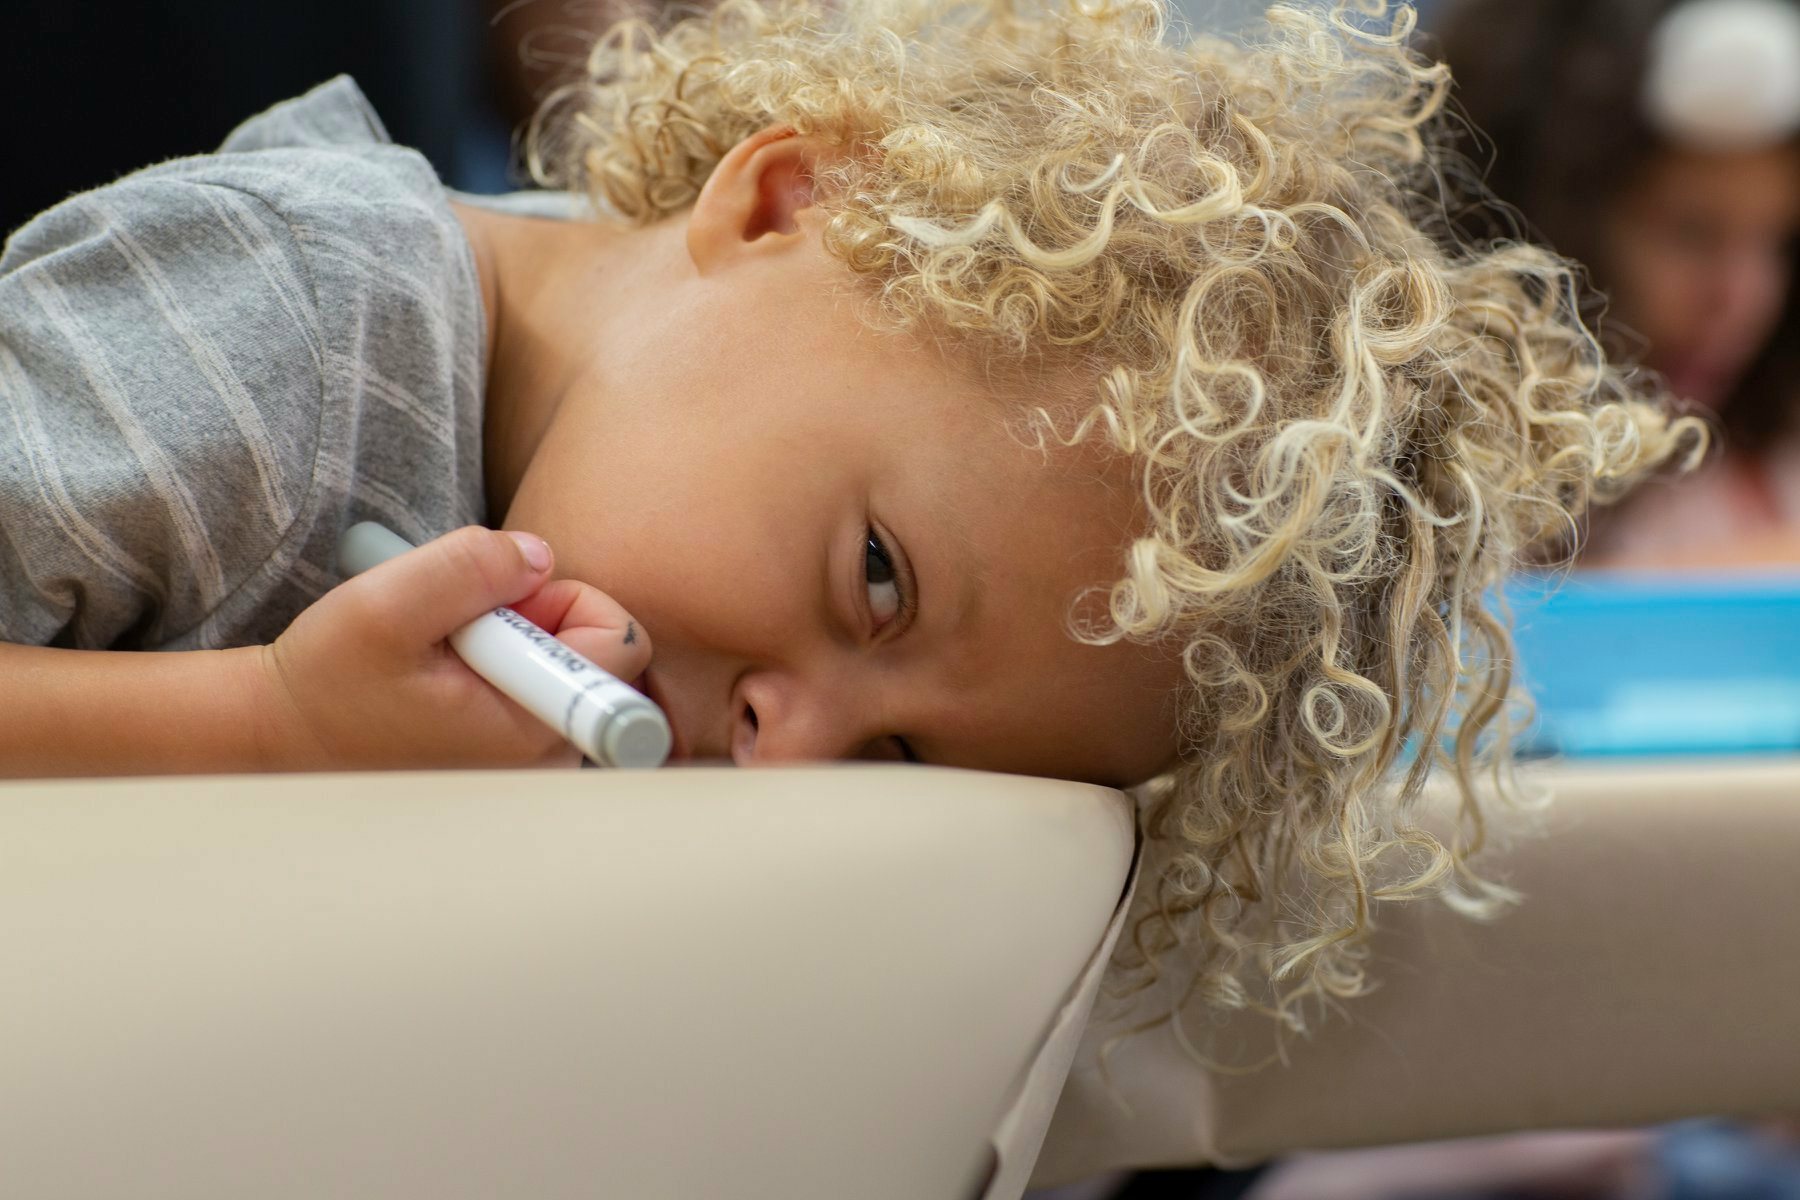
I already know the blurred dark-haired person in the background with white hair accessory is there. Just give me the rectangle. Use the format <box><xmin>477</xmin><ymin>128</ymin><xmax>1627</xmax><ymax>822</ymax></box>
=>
<box><xmin>1429</xmin><ymin>0</ymin><xmax>1800</xmax><ymax>565</ymax></box>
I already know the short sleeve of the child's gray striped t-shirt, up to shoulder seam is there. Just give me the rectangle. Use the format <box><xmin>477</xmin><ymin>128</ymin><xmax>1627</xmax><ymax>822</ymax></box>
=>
<box><xmin>0</xmin><ymin>174</ymin><xmax>324</xmax><ymax>648</ymax></box>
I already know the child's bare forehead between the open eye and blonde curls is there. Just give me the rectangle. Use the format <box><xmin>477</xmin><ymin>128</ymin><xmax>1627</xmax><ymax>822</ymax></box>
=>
<box><xmin>875</xmin><ymin>347</ymin><xmax>1181</xmax><ymax>784</ymax></box>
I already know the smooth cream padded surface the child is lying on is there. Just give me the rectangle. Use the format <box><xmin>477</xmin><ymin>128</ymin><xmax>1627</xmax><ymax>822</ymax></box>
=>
<box><xmin>0</xmin><ymin>766</ymin><xmax>1132</xmax><ymax>1200</ymax></box>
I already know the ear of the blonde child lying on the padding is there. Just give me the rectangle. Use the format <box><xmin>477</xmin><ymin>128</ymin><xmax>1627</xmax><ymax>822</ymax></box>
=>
<box><xmin>688</xmin><ymin>126</ymin><xmax>826</xmax><ymax>273</ymax></box>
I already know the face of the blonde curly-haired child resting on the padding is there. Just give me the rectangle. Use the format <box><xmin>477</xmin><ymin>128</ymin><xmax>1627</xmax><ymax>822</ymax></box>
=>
<box><xmin>504</xmin><ymin>223</ymin><xmax>1181</xmax><ymax>784</ymax></box>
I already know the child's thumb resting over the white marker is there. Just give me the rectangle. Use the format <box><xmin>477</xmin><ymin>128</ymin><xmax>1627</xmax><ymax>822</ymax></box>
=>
<box><xmin>351</xmin><ymin>525</ymin><xmax>551</xmax><ymax>642</ymax></box>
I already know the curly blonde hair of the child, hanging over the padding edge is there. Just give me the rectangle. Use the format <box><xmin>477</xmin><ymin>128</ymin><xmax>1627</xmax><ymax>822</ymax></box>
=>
<box><xmin>527</xmin><ymin>0</ymin><xmax>1705</xmax><ymax>1020</ymax></box>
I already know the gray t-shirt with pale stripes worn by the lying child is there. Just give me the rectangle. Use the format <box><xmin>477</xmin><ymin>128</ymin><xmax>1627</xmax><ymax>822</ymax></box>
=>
<box><xmin>0</xmin><ymin>77</ymin><xmax>486</xmax><ymax>649</ymax></box>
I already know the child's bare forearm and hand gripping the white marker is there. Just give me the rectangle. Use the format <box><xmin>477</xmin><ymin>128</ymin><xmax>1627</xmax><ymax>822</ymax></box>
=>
<box><xmin>0</xmin><ymin>527</ymin><xmax>650</xmax><ymax>775</ymax></box>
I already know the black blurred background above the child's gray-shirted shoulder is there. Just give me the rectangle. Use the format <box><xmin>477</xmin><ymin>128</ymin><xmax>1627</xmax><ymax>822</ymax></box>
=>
<box><xmin>0</xmin><ymin>0</ymin><xmax>511</xmax><ymax>232</ymax></box>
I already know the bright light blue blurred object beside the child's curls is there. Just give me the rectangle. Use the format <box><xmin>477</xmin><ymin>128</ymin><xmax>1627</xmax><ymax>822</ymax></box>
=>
<box><xmin>1507</xmin><ymin>574</ymin><xmax>1800</xmax><ymax>756</ymax></box>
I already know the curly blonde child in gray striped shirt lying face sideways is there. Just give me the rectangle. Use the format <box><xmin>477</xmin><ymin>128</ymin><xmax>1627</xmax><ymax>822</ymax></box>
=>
<box><xmin>0</xmin><ymin>0</ymin><xmax>1696</xmax><ymax>1021</ymax></box>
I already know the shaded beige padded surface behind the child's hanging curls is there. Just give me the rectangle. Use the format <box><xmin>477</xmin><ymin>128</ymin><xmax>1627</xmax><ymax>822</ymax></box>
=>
<box><xmin>1037</xmin><ymin>757</ymin><xmax>1800</xmax><ymax>1184</ymax></box>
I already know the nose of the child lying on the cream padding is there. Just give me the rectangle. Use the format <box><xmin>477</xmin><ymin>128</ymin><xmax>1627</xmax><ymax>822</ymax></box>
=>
<box><xmin>731</xmin><ymin>673</ymin><xmax>884</xmax><ymax>766</ymax></box>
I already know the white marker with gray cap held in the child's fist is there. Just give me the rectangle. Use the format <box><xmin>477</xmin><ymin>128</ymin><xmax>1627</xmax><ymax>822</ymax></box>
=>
<box><xmin>338</xmin><ymin>522</ymin><xmax>670</xmax><ymax>766</ymax></box>
